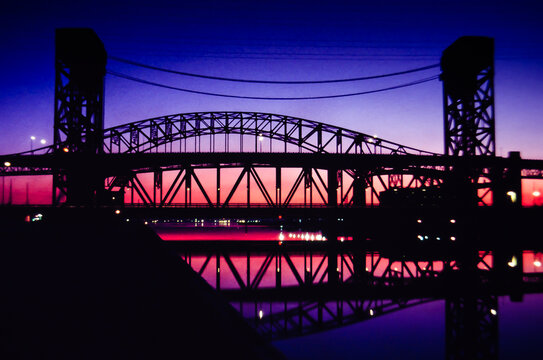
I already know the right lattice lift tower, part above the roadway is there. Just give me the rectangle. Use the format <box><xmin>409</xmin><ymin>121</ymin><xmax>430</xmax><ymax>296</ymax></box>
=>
<box><xmin>441</xmin><ymin>36</ymin><xmax>496</xmax><ymax>156</ymax></box>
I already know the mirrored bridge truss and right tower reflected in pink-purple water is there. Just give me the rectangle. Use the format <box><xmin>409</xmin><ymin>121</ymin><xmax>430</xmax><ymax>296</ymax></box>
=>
<box><xmin>150</xmin><ymin>219</ymin><xmax>543</xmax><ymax>358</ymax></box>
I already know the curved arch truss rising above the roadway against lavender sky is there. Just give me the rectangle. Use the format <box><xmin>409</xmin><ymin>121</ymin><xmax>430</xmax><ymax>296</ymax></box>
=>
<box><xmin>104</xmin><ymin>112</ymin><xmax>435</xmax><ymax>155</ymax></box>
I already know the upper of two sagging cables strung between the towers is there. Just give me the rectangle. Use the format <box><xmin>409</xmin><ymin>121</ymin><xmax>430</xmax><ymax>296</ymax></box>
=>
<box><xmin>108</xmin><ymin>56</ymin><xmax>439</xmax><ymax>85</ymax></box>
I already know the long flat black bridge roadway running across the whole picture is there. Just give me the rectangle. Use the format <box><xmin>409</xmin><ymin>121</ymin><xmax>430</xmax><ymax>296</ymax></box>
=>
<box><xmin>0</xmin><ymin>152</ymin><xmax>543</xmax><ymax>179</ymax></box>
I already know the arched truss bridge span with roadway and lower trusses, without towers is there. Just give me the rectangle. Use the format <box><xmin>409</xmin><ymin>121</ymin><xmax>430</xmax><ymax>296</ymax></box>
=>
<box><xmin>0</xmin><ymin>112</ymin><xmax>543</xmax><ymax>207</ymax></box>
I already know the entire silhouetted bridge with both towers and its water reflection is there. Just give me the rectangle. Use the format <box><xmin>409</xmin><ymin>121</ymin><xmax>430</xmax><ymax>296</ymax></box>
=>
<box><xmin>0</xmin><ymin>29</ymin><xmax>543</xmax><ymax>358</ymax></box>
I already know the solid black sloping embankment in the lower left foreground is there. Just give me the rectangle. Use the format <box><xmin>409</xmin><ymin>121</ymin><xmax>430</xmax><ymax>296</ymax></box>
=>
<box><xmin>0</xmin><ymin>208</ymin><xmax>282</xmax><ymax>359</ymax></box>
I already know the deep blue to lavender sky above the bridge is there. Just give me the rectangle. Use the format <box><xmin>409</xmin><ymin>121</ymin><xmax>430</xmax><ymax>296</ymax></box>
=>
<box><xmin>0</xmin><ymin>0</ymin><xmax>543</xmax><ymax>158</ymax></box>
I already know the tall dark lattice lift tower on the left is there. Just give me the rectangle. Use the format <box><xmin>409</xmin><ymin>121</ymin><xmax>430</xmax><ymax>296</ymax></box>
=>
<box><xmin>53</xmin><ymin>28</ymin><xmax>107</xmax><ymax>206</ymax></box>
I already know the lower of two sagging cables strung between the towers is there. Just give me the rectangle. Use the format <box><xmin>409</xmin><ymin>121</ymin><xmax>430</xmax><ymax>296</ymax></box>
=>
<box><xmin>107</xmin><ymin>70</ymin><xmax>439</xmax><ymax>101</ymax></box>
